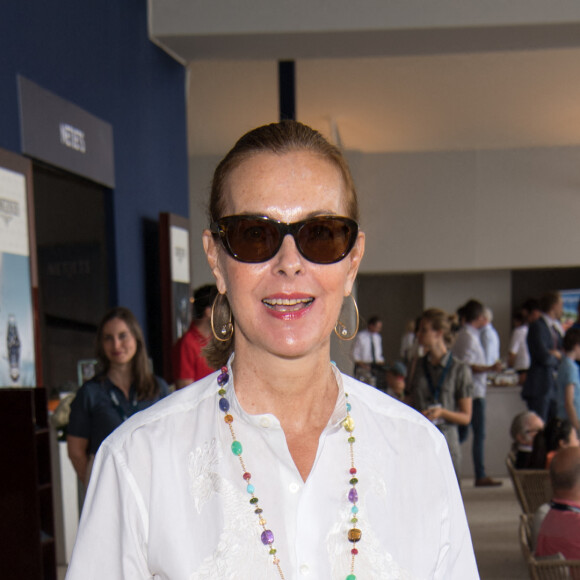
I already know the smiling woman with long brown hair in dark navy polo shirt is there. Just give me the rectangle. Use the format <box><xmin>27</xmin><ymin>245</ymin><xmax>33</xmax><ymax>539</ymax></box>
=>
<box><xmin>67</xmin><ymin>307</ymin><xmax>169</xmax><ymax>485</ymax></box>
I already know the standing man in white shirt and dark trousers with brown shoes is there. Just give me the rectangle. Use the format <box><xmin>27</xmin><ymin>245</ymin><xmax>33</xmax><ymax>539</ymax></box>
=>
<box><xmin>453</xmin><ymin>300</ymin><xmax>502</xmax><ymax>487</ymax></box>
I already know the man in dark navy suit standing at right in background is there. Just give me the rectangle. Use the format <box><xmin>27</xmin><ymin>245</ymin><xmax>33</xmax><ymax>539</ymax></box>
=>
<box><xmin>522</xmin><ymin>292</ymin><xmax>563</xmax><ymax>422</ymax></box>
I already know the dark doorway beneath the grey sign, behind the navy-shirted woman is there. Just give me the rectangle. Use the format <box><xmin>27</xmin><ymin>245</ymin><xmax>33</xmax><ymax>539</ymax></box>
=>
<box><xmin>33</xmin><ymin>164</ymin><xmax>111</xmax><ymax>395</ymax></box>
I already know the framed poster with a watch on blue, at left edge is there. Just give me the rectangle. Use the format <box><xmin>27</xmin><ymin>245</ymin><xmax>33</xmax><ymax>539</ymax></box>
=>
<box><xmin>0</xmin><ymin>149</ymin><xmax>42</xmax><ymax>387</ymax></box>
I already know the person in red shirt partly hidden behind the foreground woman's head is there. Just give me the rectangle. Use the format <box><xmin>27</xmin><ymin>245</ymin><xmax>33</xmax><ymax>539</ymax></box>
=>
<box><xmin>172</xmin><ymin>284</ymin><xmax>217</xmax><ymax>389</ymax></box>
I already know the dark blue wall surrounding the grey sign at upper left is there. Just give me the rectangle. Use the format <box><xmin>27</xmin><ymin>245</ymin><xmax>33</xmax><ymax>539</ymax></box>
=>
<box><xmin>0</xmin><ymin>0</ymin><xmax>189</xmax><ymax>348</ymax></box>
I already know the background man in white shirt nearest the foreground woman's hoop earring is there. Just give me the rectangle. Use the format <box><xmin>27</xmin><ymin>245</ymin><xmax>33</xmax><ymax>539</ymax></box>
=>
<box><xmin>352</xmin><ymin>316</ymin><xmax>385</xmax><ymax>387</ymax></box>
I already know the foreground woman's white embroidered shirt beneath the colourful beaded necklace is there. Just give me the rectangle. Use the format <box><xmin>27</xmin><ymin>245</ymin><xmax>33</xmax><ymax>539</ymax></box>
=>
<box><xmin>66</xmin><ymin>360</ymin><xmax>479</xmax><ymax>580</ymax></box>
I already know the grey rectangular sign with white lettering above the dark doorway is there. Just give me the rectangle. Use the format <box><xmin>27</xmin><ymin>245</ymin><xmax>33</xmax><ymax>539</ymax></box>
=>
<box><xmin>18</xmin><ymin>76</ymin><xmax>115</xmax><ymax>187</ymax></box>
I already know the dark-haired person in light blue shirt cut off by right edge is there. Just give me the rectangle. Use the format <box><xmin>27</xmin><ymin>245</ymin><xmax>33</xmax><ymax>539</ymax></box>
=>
<box><xmin>556</xmin><ymin>327</ymin><xmax>580</xmax><ymax>432</ymax></box>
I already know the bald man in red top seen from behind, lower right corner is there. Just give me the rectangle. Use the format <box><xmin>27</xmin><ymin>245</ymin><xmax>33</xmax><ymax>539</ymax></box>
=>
<box><xmin>536</xmin><ymin>447</ymin><xmax>580</xmax><ymax>560</ymax></box>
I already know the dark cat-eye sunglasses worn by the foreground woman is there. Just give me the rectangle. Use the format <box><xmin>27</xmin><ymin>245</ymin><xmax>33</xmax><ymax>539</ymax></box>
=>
<box><xmin>210</xmin><ymin>215</ymin><xmax>358</xmax><ymax>264</ymax></box>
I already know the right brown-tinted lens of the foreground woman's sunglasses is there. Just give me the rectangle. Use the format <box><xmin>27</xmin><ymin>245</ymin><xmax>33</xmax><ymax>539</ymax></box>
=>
<box><xmin>297</xmin><ymin>217</ymin><xmax>358</xmax><ymax>264</ymax></box>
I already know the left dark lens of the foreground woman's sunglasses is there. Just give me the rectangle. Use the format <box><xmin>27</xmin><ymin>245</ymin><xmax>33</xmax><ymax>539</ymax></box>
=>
<box><xmin>226</xmin><ymin>218</ymin><xmax>280</xmax><ymax>262</ymax></box>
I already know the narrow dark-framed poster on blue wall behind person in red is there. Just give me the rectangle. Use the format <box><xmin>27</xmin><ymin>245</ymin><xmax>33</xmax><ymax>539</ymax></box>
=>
<box><xmin>159</xmin><ymin>213</ymin><xmax>192</xmax><ymax>382</ymax></box>
